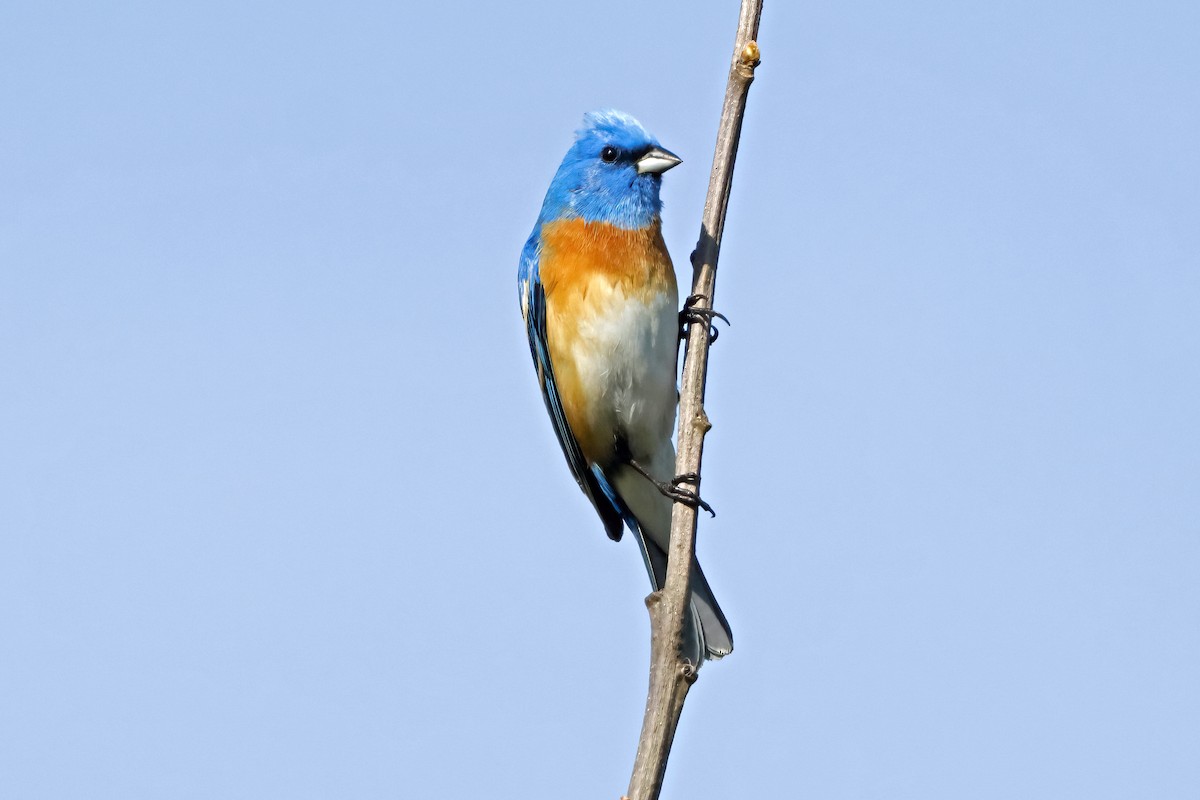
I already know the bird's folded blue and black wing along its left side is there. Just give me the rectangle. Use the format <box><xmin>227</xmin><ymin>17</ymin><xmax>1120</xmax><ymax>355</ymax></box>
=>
<box><xmin>517</xmin><ymin>222</ymin><xmax>629</xmax><ymax>541</ymax></box>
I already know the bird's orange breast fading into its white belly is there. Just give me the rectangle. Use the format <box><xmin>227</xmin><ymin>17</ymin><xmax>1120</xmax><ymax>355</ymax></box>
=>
<box><xmin>540</xmin><ymin>219</ymin><xmax>678</xmax><ymax>464</ymax></box>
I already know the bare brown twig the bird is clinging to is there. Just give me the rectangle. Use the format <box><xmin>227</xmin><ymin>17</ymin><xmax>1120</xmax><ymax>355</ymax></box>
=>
<box><xmin>628</xmin><ymin>0</ymin><xmax>762</xmax><ymax>800</ymax></box>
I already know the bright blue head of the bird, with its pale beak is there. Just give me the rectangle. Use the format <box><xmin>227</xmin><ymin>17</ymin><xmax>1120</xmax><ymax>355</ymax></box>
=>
<box><xmin>538</xmin><ymin>109</ymin><xmax>679</xmax><ymax>229</ymax></box>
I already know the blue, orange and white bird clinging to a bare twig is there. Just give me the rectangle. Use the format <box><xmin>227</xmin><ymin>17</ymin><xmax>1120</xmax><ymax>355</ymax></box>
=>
<box><xmin>517</xmin><ymin>109</ymin><xmax>733</xmax><ymax>668</ymax></box>
